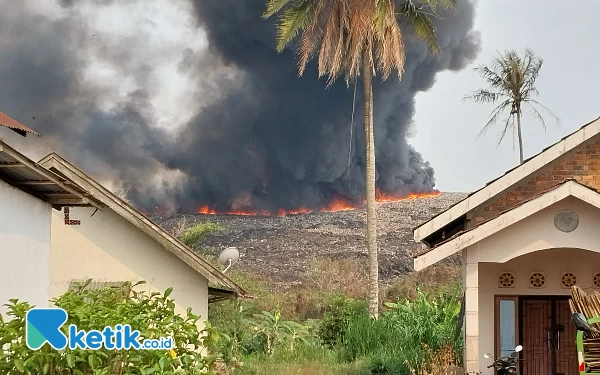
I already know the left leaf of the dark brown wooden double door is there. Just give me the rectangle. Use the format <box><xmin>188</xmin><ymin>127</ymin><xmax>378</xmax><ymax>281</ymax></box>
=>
<box><xmin>521</xmin><ymin>299</ymin><xmax>552</xmax><ymax>375</ymax></box>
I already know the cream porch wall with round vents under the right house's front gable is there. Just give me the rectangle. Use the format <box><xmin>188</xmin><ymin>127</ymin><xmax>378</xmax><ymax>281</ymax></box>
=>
<box><xmin>463</xmin><ymin>198</ymin><xmax>600</xmax><ymax>375</ymax></box>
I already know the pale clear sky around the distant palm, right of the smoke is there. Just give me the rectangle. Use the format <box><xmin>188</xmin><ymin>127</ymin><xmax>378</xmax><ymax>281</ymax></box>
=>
<box><xmin>410</xmin><ymin>0</ymin><xmax>600</xmax><ymax>192</ymax></box>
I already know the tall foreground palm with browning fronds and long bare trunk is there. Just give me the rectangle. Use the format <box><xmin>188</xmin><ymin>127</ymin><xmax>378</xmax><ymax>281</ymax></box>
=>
<box><xmin>263</xmin><ymin>0</ymin><xmax>455</xmax><ymax>317</ymax></box>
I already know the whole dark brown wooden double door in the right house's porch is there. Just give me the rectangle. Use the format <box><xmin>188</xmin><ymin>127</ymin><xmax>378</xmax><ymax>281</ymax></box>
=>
<box><xmin>519</xmin><ymin>296</ymin><xmax>579</xmax><ymax>375</ymax></box>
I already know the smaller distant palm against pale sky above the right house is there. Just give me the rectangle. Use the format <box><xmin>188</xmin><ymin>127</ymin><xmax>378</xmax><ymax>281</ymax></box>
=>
<box><xmin>464</xmin><ymin>50</ymin><xmax>559</xmax><ymax>164</ymax></box>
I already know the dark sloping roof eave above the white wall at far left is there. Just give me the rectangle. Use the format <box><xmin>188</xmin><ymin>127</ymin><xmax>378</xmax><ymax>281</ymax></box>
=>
<box><xmin>0</xmin><ymin>140</ymin><xmax>104</xmax><ymax>209</ymax></box>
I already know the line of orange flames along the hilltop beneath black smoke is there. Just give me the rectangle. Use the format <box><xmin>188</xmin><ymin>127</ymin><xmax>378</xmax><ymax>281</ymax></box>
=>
<box><xmin>198</xmin><ymin>188</ymin><xmax>442</xmax><ymax>216</ymax></box>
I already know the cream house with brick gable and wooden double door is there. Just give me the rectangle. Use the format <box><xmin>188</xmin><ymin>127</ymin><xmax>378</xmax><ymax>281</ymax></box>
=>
<box><xmin>414</xmin><ymin>118</ymin><xmax>600</xmax><ymax>375</ymax></box>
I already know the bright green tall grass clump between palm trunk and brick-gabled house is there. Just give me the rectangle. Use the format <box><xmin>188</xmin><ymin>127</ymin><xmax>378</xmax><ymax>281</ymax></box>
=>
<box><xmin>342</xmin><ymin>291</ymin><xmax>462</xmax><ymax>374</ymax></box>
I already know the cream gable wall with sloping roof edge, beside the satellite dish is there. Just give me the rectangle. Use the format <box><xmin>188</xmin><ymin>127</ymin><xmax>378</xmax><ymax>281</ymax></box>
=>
<box><xmin>40</xmin><ymin>153</ymin><xmax>247</xmax><ymax>325</ymax></box>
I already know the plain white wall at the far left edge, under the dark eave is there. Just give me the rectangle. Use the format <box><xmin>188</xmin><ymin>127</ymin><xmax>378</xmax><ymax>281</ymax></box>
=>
<box><xmin>0</xmin><ymin>180</ymin><xmax>52</xmax><ymax>313</ymax></box>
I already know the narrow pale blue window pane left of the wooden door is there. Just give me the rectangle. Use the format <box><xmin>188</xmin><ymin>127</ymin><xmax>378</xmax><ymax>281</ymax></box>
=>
<box><xmin>496</xmin><ymin>297</ymin><xmax>517</xmax><ymax>356</ymax></box>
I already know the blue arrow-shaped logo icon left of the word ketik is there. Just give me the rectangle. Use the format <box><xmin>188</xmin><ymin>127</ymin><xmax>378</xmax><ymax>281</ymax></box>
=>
<box><xmin>25</xmin><ymin>308</ymin><xmax>68</xmax><ymax>350</ymax></box>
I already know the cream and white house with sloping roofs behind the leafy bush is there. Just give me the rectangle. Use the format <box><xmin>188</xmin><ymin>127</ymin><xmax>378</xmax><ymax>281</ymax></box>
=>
<box><xmin>0</xmin><ymin>118</ymin><xmax>247</xmax><ymax>325</ymax></box>
